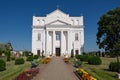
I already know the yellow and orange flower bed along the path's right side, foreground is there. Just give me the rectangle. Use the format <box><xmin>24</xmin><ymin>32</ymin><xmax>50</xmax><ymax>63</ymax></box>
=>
<box><xmin>75</xmin><ymin>68</ymin><xmax>97</xmax><ymax>80</ymax></box>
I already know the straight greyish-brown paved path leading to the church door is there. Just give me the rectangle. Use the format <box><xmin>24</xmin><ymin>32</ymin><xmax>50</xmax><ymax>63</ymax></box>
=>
<box><xmin>34</xmin><ymin>57</ymin><xmax>79</xmax><ymax>80</ymax></box>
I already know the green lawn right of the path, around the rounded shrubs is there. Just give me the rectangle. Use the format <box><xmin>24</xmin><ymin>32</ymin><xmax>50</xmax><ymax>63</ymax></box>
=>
<box><xmin>82</xmin><ymin>57</ymin><xmax>118</xmax><ymax>80</ymax></box>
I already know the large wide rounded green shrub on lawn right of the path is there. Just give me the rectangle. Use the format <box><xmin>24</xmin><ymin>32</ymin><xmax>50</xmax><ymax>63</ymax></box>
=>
<box><xmin>88</xmin><ymin>56</ymin><xmax>102</xmax><ymax>65</ymax></box>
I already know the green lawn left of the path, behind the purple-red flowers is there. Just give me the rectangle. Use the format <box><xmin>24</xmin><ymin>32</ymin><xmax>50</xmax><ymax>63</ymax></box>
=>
<box><xmin>0</xmin><ymin>61</ymin><xmax>31</xmax><ymax>80</ymax></box>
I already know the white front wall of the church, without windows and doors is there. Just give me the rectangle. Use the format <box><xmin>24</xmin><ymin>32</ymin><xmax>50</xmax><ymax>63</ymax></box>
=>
<box><xmin>32</xmin><ymin>10</ymin><xmax>84</xmax><ymax>54</ymax></box>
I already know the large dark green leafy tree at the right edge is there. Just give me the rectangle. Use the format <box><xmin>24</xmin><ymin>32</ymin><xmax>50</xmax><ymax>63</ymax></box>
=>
<box><xmin>96</xmin><ymin>7</ymin><xmax>120</xmax><ymax>71</ymax></box>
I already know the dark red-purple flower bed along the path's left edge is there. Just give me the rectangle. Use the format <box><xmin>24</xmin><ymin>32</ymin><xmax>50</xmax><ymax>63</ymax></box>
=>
<box><xmin>14</xmin><ymin>68</ymin><xmax>39</xmax><ymax>80</ymax></box>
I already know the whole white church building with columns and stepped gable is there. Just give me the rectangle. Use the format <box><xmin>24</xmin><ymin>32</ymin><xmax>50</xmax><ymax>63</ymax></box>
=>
<box><xmin>32</xmin><ymin>9</ymin><xmax>84</xmax><ymax>56</ymax></box>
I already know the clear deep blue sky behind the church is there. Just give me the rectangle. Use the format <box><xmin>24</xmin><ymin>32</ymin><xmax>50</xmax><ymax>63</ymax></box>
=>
<box><xmin>0</xmin><ymin>0</ymin><xmax>120</xmax><ymax>52</ymax></box>
